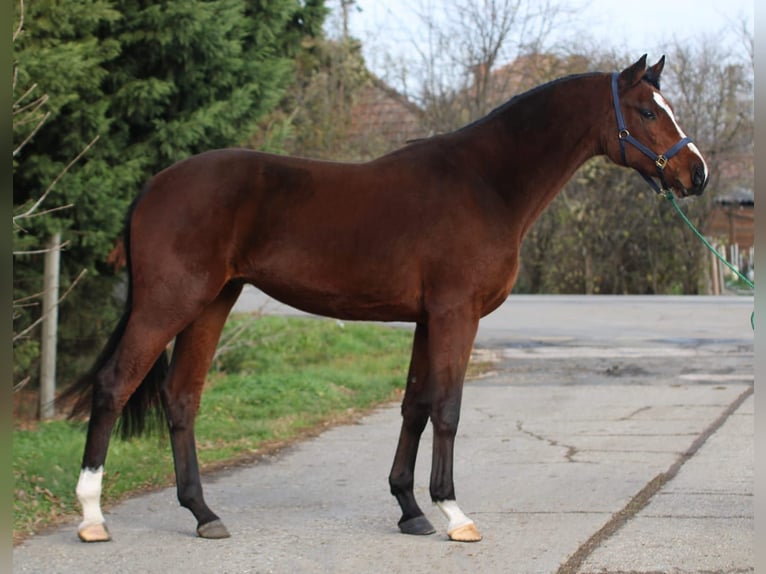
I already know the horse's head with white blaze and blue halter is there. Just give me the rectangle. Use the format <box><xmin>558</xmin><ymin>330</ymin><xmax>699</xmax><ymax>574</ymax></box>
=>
<box><xmin>606</xmin><ymin>55</ymin><xmax>709</xmax><ymax>196</ymax></box>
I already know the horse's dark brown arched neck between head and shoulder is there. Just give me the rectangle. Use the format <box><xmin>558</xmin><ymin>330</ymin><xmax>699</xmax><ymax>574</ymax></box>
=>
<box><xmin>461</xmin><ymin>77</ymin><xmax>608</xmax><ymax>235</ymax></box>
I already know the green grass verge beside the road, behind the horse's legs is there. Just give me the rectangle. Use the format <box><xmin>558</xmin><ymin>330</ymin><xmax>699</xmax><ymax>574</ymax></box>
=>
<box><xmin>13</xmin><ymin>315</ymin><xmax>411</xmax><ymax>542</ymax></box>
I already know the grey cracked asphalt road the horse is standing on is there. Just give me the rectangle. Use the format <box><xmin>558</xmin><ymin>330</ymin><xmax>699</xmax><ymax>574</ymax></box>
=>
<box><xmin>13</xmin><ymin>292</ymin><xmax>755</xmax><ymax>574</ymax></box>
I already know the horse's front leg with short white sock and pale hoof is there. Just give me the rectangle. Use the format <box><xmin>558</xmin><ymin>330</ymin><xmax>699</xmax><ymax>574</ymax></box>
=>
<box><xmin>429</xmin><ymin>313</ymin><xmax>481</xmax><ymax>542</ymax></box>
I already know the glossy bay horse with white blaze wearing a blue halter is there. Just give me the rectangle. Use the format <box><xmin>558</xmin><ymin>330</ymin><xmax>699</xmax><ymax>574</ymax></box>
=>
<box><xmin>60</xmin><ymin>56</ymin><xmax>708</xmax><ymax>541</ymax></box>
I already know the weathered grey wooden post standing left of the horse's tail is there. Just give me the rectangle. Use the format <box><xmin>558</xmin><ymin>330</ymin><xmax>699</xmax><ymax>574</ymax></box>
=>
<box><xmin>40</xmin><ymin>233</ymin><xmax>61</xmax><ymax>420</ymax></box>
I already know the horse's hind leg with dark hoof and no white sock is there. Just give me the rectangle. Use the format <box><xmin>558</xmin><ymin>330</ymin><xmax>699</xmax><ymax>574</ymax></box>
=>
<box><xmin>162</xmin><ymin>283</ymin><xmax>242</xmax><ymax>538</ymax></box>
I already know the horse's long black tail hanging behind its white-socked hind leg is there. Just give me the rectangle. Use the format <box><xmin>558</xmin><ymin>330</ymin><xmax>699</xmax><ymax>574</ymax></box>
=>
<box><xmin>56</xmin><ymin>192</ymin><xmax>168</xmax><ymax>439</ymax></box>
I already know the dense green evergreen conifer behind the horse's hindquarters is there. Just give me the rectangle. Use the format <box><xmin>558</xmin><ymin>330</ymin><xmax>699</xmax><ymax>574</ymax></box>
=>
<box><xmin>14</xmin><ymin>0</ymin><xmax>326</xmax><ymax>392</ymax></box>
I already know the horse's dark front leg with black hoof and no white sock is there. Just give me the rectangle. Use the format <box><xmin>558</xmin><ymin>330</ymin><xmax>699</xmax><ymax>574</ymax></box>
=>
<box><xmin>388</xmin><ymin>323</ymin><xmax>434</xmax><ymax>534</ymax></box>
